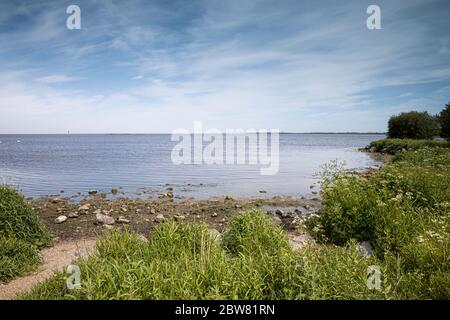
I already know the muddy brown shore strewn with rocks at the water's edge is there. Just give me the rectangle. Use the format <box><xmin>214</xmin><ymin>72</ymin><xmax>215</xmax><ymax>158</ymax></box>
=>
<box><xmin>28</xmin><ymin>186</ymin><xmax>321</xmax><ymax>242</ymax></box>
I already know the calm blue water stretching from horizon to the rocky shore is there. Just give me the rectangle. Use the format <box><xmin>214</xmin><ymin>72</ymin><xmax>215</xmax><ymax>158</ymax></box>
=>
<box><xmin>0</xmin><ymin>134</ymin><xmax>382</xmax><ymax>198</ymax></box>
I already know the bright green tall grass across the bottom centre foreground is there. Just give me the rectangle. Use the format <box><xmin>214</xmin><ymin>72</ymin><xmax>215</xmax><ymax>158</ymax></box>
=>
<box><xmin>20</xmin><ymin>211</ymin><xmax>391</xmax><ymax>299</ymax></box>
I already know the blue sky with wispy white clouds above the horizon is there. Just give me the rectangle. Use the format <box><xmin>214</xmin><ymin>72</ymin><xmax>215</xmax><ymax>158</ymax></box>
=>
<box><xmin>0</xmin><ymin>0</ymin><xmax>450</xmax><ymax>134</ymax></box>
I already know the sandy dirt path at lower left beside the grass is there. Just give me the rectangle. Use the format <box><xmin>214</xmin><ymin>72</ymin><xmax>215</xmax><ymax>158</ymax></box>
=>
<box><xmin>0</xmin><ymin>239</ymin><xmax>95</xmax><ymax>300</ymax></box>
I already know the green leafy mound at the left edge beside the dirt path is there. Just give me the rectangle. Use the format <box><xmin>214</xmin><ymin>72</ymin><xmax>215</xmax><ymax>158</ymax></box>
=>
<box><xmin>0</xmin><ymin>187</ymin><xmax>50</xmax><ymax>282</ymax></box>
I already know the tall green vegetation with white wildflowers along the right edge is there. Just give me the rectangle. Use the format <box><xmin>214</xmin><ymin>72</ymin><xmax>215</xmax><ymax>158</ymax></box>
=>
<box><xmin>310</xmin><ymin>148</ymin><xmax>450</xmax><ymax>299</ymax></box>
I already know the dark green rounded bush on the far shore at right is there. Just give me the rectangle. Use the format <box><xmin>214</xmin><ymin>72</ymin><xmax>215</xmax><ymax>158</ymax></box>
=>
<box><xmin>388</xmin><ymin>111</ymin><xmax>440</xmax><ymax>139</ymax></box>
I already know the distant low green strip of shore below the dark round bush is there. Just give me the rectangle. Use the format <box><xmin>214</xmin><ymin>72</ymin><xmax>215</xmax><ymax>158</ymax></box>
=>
<box><xmin>367</xmin><ymin>139</ymin><xmax>450</xmax><ymax>154</ymax></box>
